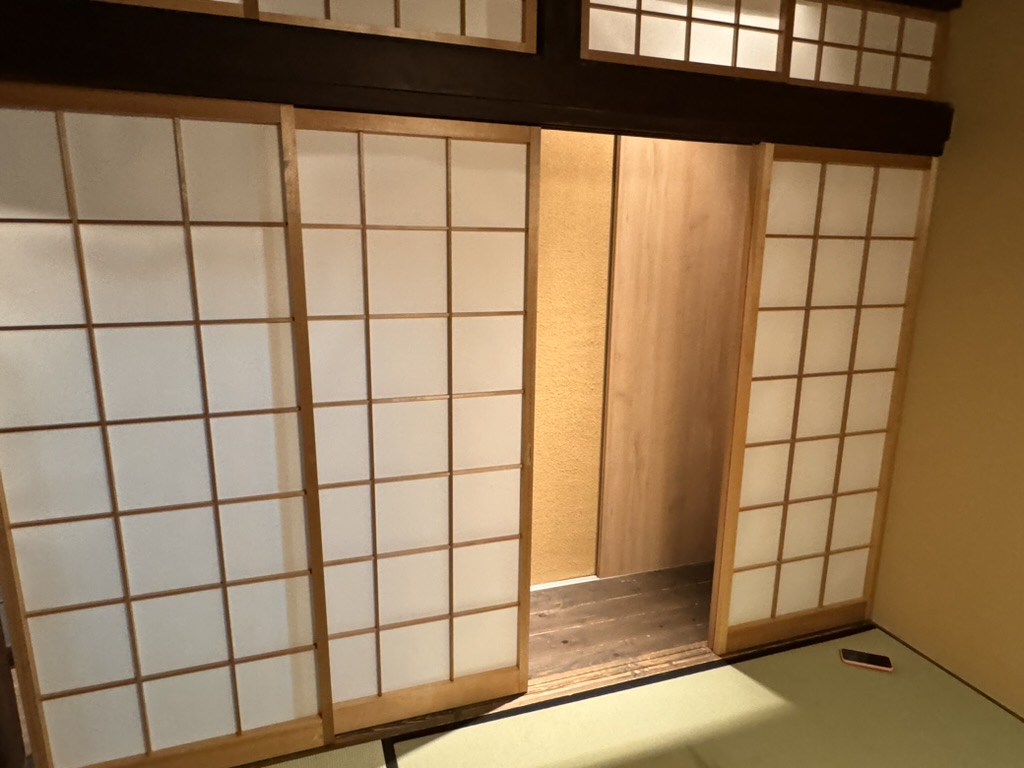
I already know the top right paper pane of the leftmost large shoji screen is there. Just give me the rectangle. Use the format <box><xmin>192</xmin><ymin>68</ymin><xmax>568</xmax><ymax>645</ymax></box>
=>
<box><xmin>181</xmin><ymin>120</ymin><xmax>285</xmax><ymax>221</ymax></box>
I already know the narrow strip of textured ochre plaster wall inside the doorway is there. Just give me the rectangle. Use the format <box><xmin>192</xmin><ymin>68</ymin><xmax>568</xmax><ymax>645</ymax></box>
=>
<box><xmin>531</xmin><ymin>131</ymin><xmax>614</xmax><ymax>584</ymax></box>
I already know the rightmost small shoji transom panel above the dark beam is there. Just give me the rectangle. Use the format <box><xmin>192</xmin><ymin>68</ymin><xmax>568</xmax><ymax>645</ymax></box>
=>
<box><xmin>787</xmin><ymin>0</ymin><xmax>945</xmax><ymax>95</ymax></box>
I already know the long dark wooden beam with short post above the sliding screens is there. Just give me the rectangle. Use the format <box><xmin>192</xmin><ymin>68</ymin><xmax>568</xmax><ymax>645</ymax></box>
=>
<box><xmin>0</xmin><ymin>0</ymin><xmax>952</xmax><ymax>155</ymax></box>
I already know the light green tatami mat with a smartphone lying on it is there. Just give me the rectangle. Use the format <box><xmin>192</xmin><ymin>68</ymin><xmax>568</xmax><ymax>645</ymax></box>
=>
<box><xmin>389</xmin><ymin>630</ymin><xmax>1024</xmax><ymax>768</ymax></box>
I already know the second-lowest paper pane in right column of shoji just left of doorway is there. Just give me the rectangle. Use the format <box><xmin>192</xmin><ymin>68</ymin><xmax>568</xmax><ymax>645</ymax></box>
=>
<box><xmin>454</xmin><ymin>541</ymin><xmax>519</xmax><ymax>611</ymax></box>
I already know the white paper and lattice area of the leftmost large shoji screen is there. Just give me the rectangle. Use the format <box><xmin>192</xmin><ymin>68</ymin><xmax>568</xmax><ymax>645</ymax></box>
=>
<box><xmin>0</xmin><ymin>97</ymin><xmax>318</xmax><ymax>768</ymax></box>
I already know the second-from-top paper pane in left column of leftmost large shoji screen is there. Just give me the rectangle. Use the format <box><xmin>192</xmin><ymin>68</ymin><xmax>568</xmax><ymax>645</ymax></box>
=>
<box><xmin>0</xmin><ymin>225</ymin><xmax>85</xmax><ymax>326</ymax></box>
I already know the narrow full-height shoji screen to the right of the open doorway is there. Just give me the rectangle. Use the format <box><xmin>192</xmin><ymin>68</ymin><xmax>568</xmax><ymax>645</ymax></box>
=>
<box><xmin>716</xmin><ymin>147</ymin><xmax>932</xmax><ymax>650</ymax></box>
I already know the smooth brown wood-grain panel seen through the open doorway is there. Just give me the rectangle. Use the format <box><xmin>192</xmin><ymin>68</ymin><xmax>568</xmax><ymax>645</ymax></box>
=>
<box><xmin>598</xmin><ymin>137</ymin><xmax>755</xmax><ymax>577</ymax></box>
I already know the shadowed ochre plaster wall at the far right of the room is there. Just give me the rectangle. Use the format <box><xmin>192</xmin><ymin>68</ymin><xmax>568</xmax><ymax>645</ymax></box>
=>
<box><xmin>873</xmin><ymin>0</ymin><xmax>1024</xmax><ymax>715</ymax></box>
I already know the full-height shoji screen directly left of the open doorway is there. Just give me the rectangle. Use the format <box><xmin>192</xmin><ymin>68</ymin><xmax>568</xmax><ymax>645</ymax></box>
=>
<box><xmin>296</xmin><ymin>111</ymin><xmax>538</xmax><ymax>731</ymax></box>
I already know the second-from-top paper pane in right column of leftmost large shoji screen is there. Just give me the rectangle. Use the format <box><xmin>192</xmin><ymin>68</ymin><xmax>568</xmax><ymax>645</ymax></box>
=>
<box><xmin>191</xmin><ymin>226</ymin><xmax>291</xmax><ymax>319</ymax></box>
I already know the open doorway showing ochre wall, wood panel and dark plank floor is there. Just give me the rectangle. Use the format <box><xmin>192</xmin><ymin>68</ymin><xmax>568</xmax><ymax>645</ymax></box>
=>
<box><xmin>527</xmin><ymin>131</ymin><xmax>757</xmax><ymax>698</ymax></box>
